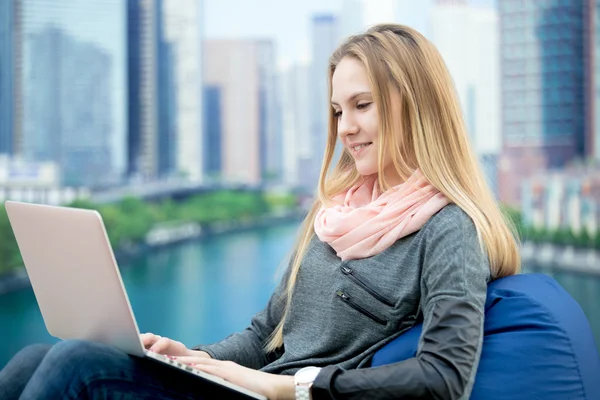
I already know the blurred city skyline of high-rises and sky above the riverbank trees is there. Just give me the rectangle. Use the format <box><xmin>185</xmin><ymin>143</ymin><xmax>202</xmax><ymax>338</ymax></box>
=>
<box><xmin>0</xmin><ymin>0</ymin><xmax>600</xmax><ymax>241</ymax></box>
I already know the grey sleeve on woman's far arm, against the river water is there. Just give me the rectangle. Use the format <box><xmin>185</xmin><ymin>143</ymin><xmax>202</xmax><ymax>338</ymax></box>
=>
<box><xmin>192</xmin><ymin>264</ymin><xmax>291</xmax><ymax>369</ymax></box>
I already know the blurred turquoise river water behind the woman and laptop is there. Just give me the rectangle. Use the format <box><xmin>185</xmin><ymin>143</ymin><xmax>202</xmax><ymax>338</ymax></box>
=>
<box><xmin>0</xmin><ymin>224</ymin><xmax>600</xmax><ymax>366</ymax></box>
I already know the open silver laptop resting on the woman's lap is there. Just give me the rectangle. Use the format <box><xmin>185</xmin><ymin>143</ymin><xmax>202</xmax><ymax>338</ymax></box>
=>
<box><xmin>5</xmin><ymin>201</ymin><xmax>266</xmax><ymax>400</ymax></box>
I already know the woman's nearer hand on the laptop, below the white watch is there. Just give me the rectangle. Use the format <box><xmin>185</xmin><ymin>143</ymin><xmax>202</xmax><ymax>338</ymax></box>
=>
<box><xmin>175</xmin><ymin>357</ymin><xmax>295</xmax><ymax>400</ymax></box>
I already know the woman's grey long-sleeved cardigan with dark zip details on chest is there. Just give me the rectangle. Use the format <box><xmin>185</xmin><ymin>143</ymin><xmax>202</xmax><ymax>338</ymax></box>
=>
<box><xmin>196</xmin><ymin>204</ymin><xmax>490</xmax><ymax>400</ymax></box>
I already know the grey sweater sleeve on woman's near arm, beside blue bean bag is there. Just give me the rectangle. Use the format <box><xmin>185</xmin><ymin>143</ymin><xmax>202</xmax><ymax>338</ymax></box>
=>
<box><xmin>312</xmin><ymin>207</ymin><xmax>490</xmax><ymax>400</ymax></box>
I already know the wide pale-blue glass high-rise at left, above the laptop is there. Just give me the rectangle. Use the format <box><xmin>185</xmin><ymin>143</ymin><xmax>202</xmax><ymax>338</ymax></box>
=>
<box><xmin>20</xmin><ymin>0</ymin><xmax>126</xmax><ymax>187</ymax></box>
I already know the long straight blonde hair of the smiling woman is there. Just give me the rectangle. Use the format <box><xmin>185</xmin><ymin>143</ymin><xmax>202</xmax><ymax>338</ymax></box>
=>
<box><xmin>265</xmin><ymin>24</ymin><xmax>520</xmax><ymax>351</ymax></box>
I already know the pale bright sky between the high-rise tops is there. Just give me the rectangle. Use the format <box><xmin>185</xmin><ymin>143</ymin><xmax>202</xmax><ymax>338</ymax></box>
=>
<box><xmin>203</xmin><ymin>0</ymin><xmax>497</xmax><ymax>67</ymax></box>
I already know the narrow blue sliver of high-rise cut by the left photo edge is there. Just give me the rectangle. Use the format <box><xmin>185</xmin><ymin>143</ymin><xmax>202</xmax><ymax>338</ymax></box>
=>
<box><xmin>0</xmin><ymin>0</ymin><xmax>15</xmax><ymax>154</ymax></box>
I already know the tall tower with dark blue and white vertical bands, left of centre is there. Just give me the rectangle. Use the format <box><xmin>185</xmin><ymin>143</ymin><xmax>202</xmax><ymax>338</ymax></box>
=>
<box><xmin>127</xmin><ymin>0</ymin><xmax>203</xmax><ymax>181</ymax></box>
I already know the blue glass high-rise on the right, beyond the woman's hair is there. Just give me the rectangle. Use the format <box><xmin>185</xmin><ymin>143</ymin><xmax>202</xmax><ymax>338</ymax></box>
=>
<box><xmin>498</xmin><ymin>0</ymin><xmax>590</xmax><ymax>205</ymax></box>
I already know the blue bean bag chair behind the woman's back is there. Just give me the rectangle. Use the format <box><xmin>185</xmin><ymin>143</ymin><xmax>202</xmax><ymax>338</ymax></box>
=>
<box><xmin>371</xmin><ymin>274</ymin><xmax>600</xmax><ymax>400</ymax></box>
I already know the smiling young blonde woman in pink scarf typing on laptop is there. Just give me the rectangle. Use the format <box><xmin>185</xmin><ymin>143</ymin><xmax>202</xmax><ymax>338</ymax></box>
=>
<box><xmin>0</xmin><ymin>25</ymin><xmax>520</xmax><ymax>400</ymax></box>
